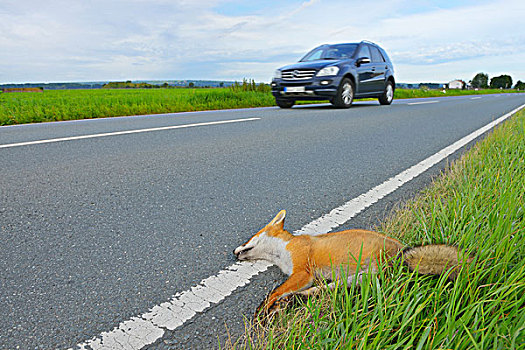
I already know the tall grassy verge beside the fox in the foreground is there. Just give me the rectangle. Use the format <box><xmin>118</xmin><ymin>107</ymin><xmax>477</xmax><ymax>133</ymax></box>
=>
<box><xmin>233</xmin><ymin>111</ymin><xmax>525</xmax><ymax>349</ymax></box>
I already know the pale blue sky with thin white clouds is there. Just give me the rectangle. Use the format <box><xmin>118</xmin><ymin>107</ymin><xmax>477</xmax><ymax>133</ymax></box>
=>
<box><xmin>0</xmin><ymin>0</ymin><xmax>525</xmax><ymax>83</ymax></box>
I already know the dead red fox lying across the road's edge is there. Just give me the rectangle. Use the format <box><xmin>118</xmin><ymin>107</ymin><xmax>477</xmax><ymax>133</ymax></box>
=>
<box><xmin>233</xmin><ymin>210</ymin><xmax>472</xmax><ymax>312</ymax></box>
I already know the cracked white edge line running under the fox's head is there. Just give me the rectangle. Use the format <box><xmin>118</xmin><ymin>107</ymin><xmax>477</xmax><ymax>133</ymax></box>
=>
<box><xmin>72</xmin><ymin>104</ymin><xmax>525</xmax><ymax>350</ymax></box>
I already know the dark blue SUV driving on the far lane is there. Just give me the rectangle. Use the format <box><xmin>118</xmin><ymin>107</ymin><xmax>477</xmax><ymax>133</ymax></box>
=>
<box><xmin>272</xmin><ymin>41</ymin><xmax>396</xmax><ymax>108</ymax></box>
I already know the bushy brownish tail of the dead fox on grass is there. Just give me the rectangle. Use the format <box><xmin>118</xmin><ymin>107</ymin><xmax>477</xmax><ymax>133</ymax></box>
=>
<box><xmin>403</xmin><ymin>244</ymin><xmax>473</xmax><ymax>279</ymax></box>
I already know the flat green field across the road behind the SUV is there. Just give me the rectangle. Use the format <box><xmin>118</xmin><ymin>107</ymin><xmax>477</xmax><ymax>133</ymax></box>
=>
<box><xmin>0</xmin><ymin>84</ymin><xmax>520</xmax><ymax>125</ymax></box>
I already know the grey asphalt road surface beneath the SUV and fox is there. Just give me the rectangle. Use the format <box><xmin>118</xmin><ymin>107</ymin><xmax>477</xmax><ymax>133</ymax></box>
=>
<box><xmin>0</xmin><ymin>94</ymin><xmax>525</xmax><ymax>349</ymax></box>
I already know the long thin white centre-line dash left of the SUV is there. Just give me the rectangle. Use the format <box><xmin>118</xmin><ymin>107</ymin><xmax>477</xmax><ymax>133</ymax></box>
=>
<box><xmin>0</xmin><ymin>118</ymin><xmax>261</xmax><ymax>148</ymax></box>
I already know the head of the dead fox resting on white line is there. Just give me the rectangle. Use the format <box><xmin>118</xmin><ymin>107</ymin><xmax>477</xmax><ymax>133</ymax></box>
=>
<box><xmin>233</xmin><ymin>210</ymin><xmax>293</xmax><ymax>263</ymax></box>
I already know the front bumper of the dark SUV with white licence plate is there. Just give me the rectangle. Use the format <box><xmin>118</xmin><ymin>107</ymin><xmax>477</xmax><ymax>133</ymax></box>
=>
<box><xmin>271</xmin><ymin>76</ymin><xmax>341</xmax><ymax>100</ymax></box>
